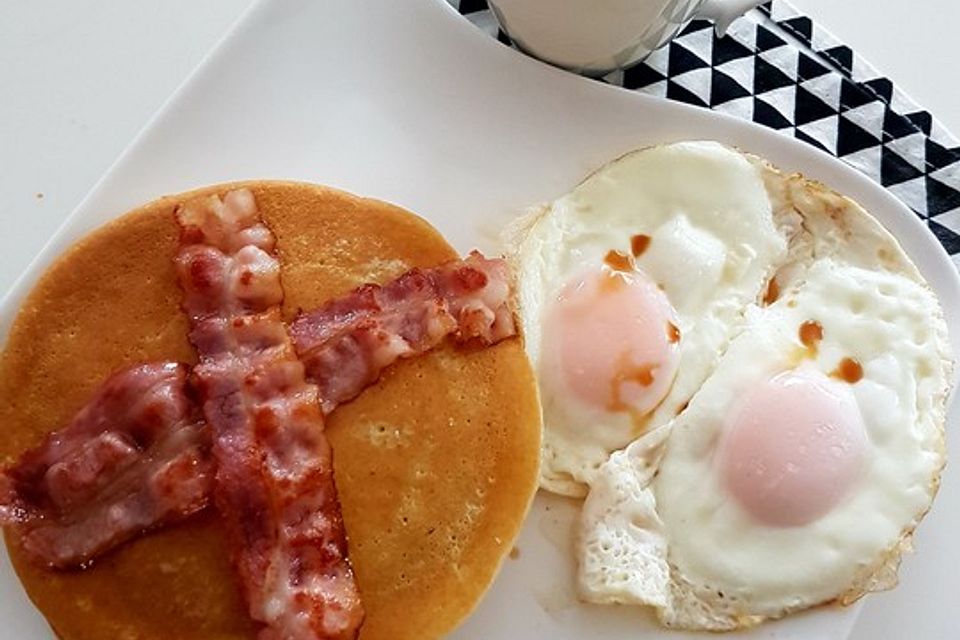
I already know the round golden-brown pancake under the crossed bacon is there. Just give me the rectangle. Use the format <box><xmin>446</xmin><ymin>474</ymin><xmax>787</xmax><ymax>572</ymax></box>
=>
<box><xmin>0</xmin><ymin>182</ymin><xmax>540</xmax><ymax>640</ymax></box>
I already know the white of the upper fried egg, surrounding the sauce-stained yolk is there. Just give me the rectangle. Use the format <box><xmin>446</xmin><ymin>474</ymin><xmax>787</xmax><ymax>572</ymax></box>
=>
<box><xmin>508</xmin><ymin>142</ymin><xmax>796</xmax><ymax>496</ymax></box>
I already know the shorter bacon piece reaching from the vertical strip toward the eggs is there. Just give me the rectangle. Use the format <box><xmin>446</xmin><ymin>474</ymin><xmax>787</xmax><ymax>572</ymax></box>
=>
<box><xmin>290</xmin><ymin>251</ymin><xmax>516</xmax><ymax>413</ymax></box>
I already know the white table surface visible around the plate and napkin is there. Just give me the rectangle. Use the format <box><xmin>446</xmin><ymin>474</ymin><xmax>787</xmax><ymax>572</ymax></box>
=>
<box><xmin>0</xmin><ymin>0</ymin><xmax>960</xmax><ymax>640</ymax></box>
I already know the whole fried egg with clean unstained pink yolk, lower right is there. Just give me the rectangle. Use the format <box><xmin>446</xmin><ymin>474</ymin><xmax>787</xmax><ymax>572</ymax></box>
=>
<box><xmin>578</xmin><ymin>160</ymin><xmax>952</xmax><ymax>631</ymax></box>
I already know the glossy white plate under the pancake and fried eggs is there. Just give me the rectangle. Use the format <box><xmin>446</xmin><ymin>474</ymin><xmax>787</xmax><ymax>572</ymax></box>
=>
<box><xmin>0</xmin><ymin>0</ymin><xmax>960</xmax><ymax>640</ymax></box>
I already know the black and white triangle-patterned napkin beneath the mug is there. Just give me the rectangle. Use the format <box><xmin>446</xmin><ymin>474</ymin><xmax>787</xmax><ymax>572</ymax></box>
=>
<box><xmin>448</xmin><ymin>0</ymin><xmax>960</xmax><ymax>267</ymax></box>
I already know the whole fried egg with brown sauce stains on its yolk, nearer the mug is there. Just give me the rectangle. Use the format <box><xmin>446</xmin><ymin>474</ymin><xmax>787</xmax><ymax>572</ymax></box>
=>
<box><xmin>507</xmin><ymin>142</ymin><xmax>796</xmax><ymax>496</ymax></box>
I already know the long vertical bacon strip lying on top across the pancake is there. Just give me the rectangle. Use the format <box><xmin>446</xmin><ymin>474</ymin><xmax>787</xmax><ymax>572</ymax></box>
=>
<box><xmin>176</xmin><ymin>190</ymin><xmax>363</xmax><ymax>640</ymax></box>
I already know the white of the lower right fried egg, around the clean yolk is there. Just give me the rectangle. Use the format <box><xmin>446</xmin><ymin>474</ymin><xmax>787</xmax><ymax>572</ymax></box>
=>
<box><xmin>578</xmin><ymin>163</ymin><xmax>951</xmax><ymax>630</ymax></box>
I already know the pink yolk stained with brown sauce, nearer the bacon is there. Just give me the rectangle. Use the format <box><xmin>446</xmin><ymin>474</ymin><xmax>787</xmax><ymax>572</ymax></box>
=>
<box><xmin>544</xmin><ymin>267</ymin><xmax>682</xmax><ymax>416</ymax></box>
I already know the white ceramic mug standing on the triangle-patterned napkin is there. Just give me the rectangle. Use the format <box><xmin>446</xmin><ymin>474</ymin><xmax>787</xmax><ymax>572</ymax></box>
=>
<box><xmin>489</xmin><ymin>0</ymin><xmax>763</xmax><ymax>75</ymax></box>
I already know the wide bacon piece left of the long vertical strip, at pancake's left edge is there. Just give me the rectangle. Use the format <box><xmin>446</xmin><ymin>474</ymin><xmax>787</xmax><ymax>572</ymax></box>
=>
<box><xmin>0</xmin><ymin>363</ymin><xmax>213</xmax><ymax>568</ymax></box>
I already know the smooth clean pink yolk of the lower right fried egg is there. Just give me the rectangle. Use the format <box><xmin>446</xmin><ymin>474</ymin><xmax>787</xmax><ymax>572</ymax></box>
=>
<box><xmin>718</xmin><ymin>368</ymin><xmax>867</xmax><ymax>527</ymax></box>
